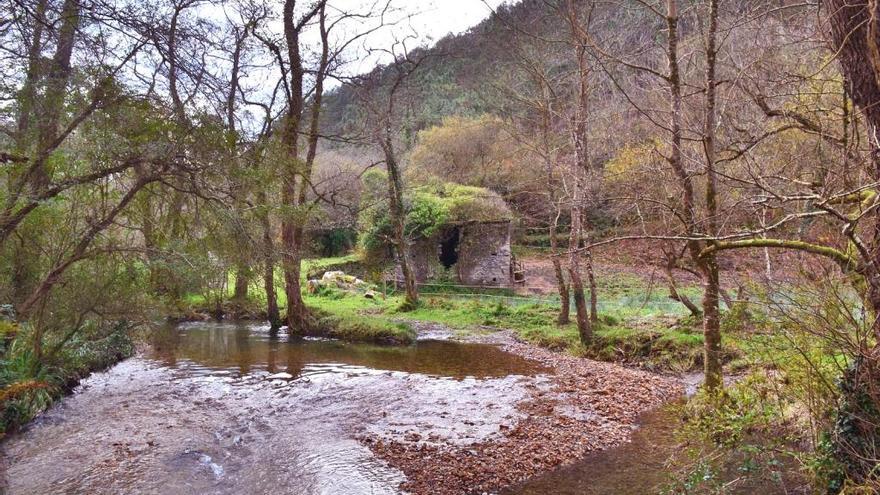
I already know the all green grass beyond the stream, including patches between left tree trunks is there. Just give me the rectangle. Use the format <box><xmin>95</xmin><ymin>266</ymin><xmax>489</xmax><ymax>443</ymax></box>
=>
<box><xmin>179</xmin><ymin>255</ymin><xmax>720</xmax><ymax>371</ymax></box>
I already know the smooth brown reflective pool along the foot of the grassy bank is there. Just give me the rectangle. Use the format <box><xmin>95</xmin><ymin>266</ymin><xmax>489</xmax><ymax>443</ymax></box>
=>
<box><xmin>149</xmin><ymin>323</ymin><xmax>544</xmax><ymax>378</ymax></box>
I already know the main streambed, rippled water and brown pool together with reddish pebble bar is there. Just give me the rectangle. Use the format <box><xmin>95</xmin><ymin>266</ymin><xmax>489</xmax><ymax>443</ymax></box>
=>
<box><xmin>0</xmin><ymin>323</ymin><xmax>678</xmax><ymax>494</ymax></box>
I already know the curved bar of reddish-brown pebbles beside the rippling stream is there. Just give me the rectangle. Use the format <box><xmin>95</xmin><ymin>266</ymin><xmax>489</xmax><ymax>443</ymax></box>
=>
<box><xmin>361</xmin><ymin>325</ymin><xmax>684</xmax><ymax>495</ymax></box>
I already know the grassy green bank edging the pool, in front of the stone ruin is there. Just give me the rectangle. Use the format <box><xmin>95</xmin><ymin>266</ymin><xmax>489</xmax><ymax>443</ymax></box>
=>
<box><xmin>306</xmin><ymin>282</ymin><xmax>720</xmax><ymax>371</ymax></box>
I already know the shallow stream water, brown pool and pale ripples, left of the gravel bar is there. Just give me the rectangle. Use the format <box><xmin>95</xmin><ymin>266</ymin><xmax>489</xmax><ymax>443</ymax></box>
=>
<box><xmin>0</xmin><ymin>323</ymin><xmax>549</xmax><ymax>494</ymax></box>
